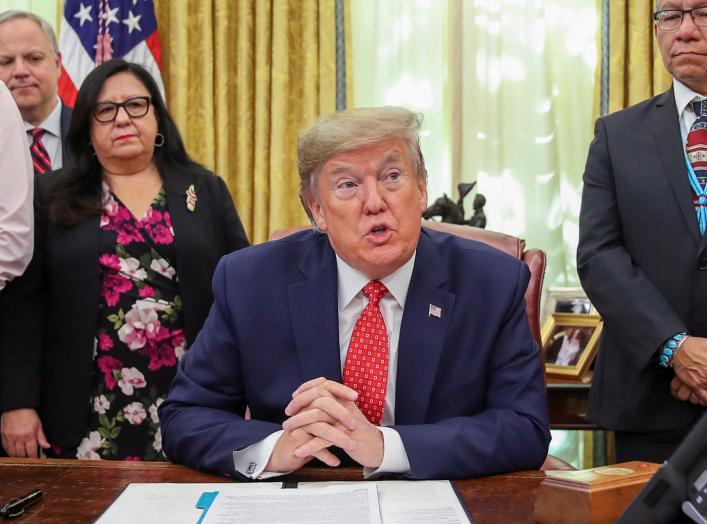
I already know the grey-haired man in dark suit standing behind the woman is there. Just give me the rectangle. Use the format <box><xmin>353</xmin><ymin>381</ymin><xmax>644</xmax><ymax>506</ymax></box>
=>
<box><xmin>0</xmin><ymin>11</ymin><xmax>71</xmax><ymax>174</ymax></box>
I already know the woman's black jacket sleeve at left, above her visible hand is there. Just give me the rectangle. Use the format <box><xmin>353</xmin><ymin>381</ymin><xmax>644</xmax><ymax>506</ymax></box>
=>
<box><xmin>0</xmin><ymin>181</ymin><xmax>46</xmax><ymax>412</ymax></box>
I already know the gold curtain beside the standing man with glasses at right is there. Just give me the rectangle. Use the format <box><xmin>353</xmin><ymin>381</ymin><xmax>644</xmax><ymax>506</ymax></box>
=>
<box><xmin>597</xmin><ymin>0</ymin><xmax>671</xmax><ymax>113</ymax></box>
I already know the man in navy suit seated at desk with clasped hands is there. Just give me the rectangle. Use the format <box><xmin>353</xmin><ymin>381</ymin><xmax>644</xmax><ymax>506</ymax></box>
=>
<box><xmin>160</xmin><ymin>108</ymin><xmax>550</xmax><ymax>479</ymax></box>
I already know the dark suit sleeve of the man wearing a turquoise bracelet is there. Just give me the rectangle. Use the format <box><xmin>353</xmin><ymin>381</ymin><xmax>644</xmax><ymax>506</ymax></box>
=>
<box><xmin>577</xmin><ymin>118</ymin><xmax>686</xmax><ymax>367</ymax></box>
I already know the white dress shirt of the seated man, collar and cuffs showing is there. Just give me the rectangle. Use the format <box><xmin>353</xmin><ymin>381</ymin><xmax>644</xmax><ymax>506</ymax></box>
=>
<box><xmin>233</xmin><ymin>253</ymin><xmax>415</xmax><ymax>479</ymax></box>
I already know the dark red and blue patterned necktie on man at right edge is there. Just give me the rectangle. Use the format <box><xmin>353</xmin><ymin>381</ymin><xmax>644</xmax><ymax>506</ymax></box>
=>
<box><xmin>685</xmin><ymin>100</ymin><xmax>707</xmax><ymax>235</ymax></box>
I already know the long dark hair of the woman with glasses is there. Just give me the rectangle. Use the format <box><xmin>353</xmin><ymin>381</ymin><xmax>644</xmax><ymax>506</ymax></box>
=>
<box><xmin>49</xmin><ymin>59</ymin><xmax>203</xmax><ymax>225</ymax></box>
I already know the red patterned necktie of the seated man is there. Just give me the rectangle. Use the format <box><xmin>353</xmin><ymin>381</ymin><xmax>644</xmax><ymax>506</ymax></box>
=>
<box><xmin>343</xmin><ymin>280</ymin><xmax>388</xmax><ymax>426</ymax></box>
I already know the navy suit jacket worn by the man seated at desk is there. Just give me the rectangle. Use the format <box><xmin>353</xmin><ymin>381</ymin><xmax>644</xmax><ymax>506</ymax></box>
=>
<box><xmin>160</xmin><ymin>228</ymin><xmax>550</xmax><ymax>478</ymax></box>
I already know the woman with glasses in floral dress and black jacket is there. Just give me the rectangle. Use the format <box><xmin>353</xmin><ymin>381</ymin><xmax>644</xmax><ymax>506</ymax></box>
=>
<box><xmin>0</xmin><ymin>60</ymin><xmax>248</xmax><ymax>460</ymax></box>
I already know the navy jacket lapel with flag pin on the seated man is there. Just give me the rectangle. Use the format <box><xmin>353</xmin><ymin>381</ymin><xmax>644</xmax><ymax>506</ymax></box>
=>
<box><xmin>395</xmin><ymin>229</ymin><xmax>455</xmax><ymax>424</ymax></box>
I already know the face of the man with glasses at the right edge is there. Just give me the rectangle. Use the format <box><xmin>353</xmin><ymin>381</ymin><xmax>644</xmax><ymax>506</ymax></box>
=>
<box><xmin>654</xmin><ymin>0</ymin><xmax>707</xmax><ymax>94</ymax></box>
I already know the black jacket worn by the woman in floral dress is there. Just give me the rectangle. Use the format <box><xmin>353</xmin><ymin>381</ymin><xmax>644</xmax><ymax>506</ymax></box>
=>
<box><xmin>0</xmin><ymin>170</ymin><xmax>248</xmax><ymax>447</ymax></box>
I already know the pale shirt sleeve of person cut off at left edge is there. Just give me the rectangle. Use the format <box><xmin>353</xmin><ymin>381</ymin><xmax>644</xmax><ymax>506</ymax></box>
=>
<box><xmin>0</xmin><ymin>81</ymin><xmax>34</xmax><ymax>290</ymax></box>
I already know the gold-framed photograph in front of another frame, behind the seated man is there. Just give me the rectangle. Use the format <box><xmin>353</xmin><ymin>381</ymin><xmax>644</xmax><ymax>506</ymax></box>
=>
<box><xmin>541</xmin><ymin>313</ymin><xmax>604</xmax><ymax>380</ymax></box>
